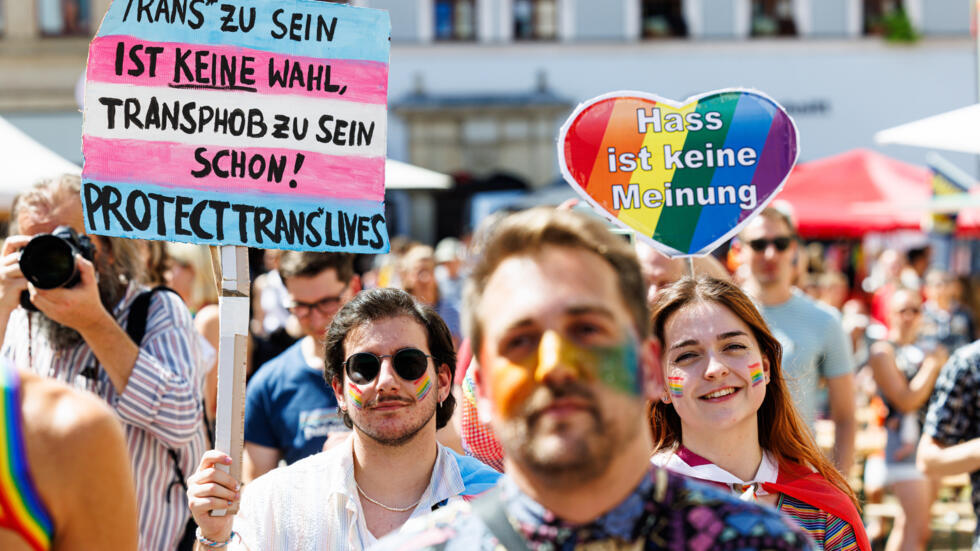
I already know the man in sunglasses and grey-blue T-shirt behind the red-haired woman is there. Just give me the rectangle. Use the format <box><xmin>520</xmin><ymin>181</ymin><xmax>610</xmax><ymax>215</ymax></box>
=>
<box><xmin>732</xmin><ymin>207</ymin><xmax>857</xmax><ymax>476</ymax></box>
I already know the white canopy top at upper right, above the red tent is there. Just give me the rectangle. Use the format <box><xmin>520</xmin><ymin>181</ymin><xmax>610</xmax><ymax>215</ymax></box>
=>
<box><xmin>875</xmin><ymin>103</ymin><xmax>980</xmax><ymax>154</ymax></box>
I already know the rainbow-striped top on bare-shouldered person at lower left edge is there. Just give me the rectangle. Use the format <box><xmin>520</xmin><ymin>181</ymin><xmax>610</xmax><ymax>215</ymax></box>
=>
<box><xmin>0</xmin><ymin>362</ymin><xmax>54</xmax><ymax>551</ymax></box>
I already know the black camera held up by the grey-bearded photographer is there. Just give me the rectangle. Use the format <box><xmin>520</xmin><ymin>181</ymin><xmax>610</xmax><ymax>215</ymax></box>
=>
<box><xmin>20</xmin><ymin>226</ymin><xmax>95</xmax><ymax>311</ymax></box>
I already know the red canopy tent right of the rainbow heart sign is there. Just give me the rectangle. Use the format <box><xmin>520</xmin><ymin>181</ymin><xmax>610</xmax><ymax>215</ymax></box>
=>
<box><xmin>777</xmin><ymin>149</ymin><xmax>980</xmax><ymax>239</ymax></box>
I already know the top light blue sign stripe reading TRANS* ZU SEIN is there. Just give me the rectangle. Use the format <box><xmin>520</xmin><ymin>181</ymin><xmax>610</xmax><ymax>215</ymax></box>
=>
<box><xmin>97</xmin><ymin>0</ymin><xmax>391</xmax><ymax>63</ymax></box>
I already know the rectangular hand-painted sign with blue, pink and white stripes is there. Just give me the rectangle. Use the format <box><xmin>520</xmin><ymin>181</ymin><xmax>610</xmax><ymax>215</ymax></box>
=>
<box><xmin>82</xmin><ymin>0</ymin><xmax>391</xmax><ymax>253</ymax></box>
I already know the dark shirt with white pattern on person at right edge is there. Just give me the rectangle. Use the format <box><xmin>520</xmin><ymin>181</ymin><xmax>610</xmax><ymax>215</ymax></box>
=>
<box><xmin>922</xmin><ymin>341</ymin><xmax>980</xmax><ymax>549</ymax></box>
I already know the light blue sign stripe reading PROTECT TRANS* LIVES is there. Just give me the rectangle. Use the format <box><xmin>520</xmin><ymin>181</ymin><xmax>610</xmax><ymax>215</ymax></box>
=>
<box><xmin>82</xmin><ymin>179</ymin><xmax>389</xmax><ymax>254</ymax></box>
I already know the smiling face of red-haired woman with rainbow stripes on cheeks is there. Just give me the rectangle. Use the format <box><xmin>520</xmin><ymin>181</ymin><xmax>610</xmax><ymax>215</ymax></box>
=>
<box><xmin>663</xmin><ymin>302</ymin><xmax>769</xmax><ymax>436</ymax></box>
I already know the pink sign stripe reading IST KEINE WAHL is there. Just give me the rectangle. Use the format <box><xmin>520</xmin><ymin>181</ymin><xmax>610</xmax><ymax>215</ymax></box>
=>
<box><xmin>87</xmin><ymin>36</ymin><xmax>388</xmax><ymax>104</ymax></box>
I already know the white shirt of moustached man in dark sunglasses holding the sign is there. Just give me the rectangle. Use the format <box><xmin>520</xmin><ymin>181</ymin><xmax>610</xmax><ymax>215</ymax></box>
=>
<box><xmin>229</xmin><ymin>439</ymin><xmax>465</xmax><ymax>551</ymax></box>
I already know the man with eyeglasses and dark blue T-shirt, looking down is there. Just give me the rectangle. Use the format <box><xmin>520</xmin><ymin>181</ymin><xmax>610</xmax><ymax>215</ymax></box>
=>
<box><xmin>242</xmin><ymin>251</ymin><xmax>360</xmax><ymax>483</ymax></box>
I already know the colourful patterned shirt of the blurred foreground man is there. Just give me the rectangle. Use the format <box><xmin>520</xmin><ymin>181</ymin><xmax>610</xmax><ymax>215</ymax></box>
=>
<box><xmin>373</xmin><ymin>466</ymin><xmax>812</xmax><ymax>551</ymax></box>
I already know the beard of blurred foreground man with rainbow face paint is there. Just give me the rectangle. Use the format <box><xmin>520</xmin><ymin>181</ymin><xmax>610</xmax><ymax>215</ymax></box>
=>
<box><xmin>500</xmin><ymin>382</ymin><xmax>636</xmax><ymax>485</ymax></box>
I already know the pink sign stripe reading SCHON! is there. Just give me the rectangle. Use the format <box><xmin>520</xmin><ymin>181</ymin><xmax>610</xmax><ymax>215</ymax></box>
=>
<box><xmin>82</xmin><ymin>136</ymin><xmax>385</xmax><ymax>201</ymax></box>
